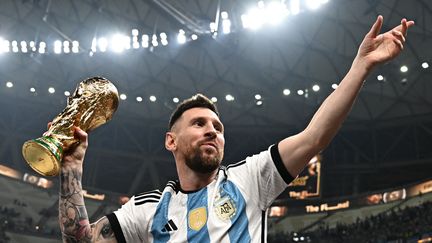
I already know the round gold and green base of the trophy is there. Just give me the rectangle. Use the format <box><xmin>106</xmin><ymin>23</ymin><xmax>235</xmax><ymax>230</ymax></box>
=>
<box><xmin>22</xmin><ymin>136</ymin><xmax>63</xmax><ymax>176</ymax></box>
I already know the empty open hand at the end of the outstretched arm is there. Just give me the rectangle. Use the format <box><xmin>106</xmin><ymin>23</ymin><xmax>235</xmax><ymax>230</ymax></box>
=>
<box><xmin>357</xmin><ymin>15</ymin><xmax>414</xmax><ymax>66</ymax></box>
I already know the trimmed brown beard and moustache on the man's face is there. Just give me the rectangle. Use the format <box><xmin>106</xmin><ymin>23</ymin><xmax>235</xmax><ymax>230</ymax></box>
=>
<box><xmin>186</xmin><ymin>143</ymin><xmax>223</xmax><ymax>174</ymax></box>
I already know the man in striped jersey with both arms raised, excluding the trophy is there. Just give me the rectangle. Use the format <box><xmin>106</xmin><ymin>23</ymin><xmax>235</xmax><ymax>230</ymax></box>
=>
<box><xmin>59</xmin><ymin>16</ymin><xmax>414</xmax><ymax>242</ymax></box>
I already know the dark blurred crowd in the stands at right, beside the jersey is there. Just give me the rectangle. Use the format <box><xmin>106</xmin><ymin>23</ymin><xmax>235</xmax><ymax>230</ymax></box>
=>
<box><xmin>268</xmin><ymin>202</ymin><xmax>432</xmax><ymax>243</ymax></box>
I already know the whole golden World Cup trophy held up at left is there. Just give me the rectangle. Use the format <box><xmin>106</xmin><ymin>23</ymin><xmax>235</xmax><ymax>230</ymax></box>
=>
<box><xmin>22</xmin><ymin>77</ymin><xmax>119</xmax><ymax>176</ymax></box>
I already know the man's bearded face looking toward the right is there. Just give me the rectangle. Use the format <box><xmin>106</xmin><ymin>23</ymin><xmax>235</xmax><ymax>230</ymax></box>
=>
<box><xmin>172</xmin><ymin>108</ymin><xmax>225</xmax><ymax>173</ymax></box>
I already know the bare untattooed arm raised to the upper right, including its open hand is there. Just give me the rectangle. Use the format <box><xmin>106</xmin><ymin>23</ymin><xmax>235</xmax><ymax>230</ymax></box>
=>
<box><xmin>278</xmin><ymin>16</ymin><xmax>414</xmax><ymax>177</ymax></box>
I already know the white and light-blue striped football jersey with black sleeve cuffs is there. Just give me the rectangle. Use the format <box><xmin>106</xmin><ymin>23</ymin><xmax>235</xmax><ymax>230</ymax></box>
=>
<box><xmin>107</xmin><ymin>145</ymin><xmax>293</xmax><ymax>243</ymax></box>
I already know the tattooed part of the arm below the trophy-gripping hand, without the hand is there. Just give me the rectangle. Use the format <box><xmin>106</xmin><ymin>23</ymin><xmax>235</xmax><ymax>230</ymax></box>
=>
<box><xmin>59</xmin><ymin>170</ymin><xmax>115</xmax><ymax>243</ymax></box>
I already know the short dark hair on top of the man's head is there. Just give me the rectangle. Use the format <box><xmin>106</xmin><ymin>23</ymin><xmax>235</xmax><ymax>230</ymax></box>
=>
<box><xmin>168</xmin><ymin>94</ymin><xmax>219</xmax><ymax>130</ymax></box>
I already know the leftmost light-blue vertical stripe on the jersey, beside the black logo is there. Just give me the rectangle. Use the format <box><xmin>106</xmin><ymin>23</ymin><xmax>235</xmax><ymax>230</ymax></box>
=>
<box><xmin>151</xmin><ymin>192</ymin><xmax>172</xmax><ymax>243</ymax></box>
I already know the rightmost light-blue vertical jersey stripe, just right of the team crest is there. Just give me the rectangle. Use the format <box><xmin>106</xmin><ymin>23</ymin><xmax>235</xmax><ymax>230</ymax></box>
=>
<box><xmin>221</xmin><ymin>180</ymin><xmax>251</xmax><ymax>242</ymax></box>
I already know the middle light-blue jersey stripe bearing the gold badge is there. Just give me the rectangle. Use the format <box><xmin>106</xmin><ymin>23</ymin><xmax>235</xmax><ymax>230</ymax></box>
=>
<box><xmin>187</xmin><ymin>187</ymin><xmax>210</xmax><ymax>243</ymax></box>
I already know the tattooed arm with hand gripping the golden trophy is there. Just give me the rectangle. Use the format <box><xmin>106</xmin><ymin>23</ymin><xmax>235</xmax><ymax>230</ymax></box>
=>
<box><xmin>59</xmin><ymin>128</ymin><xmax>117</xmax><ymax>243</ymax></box>
